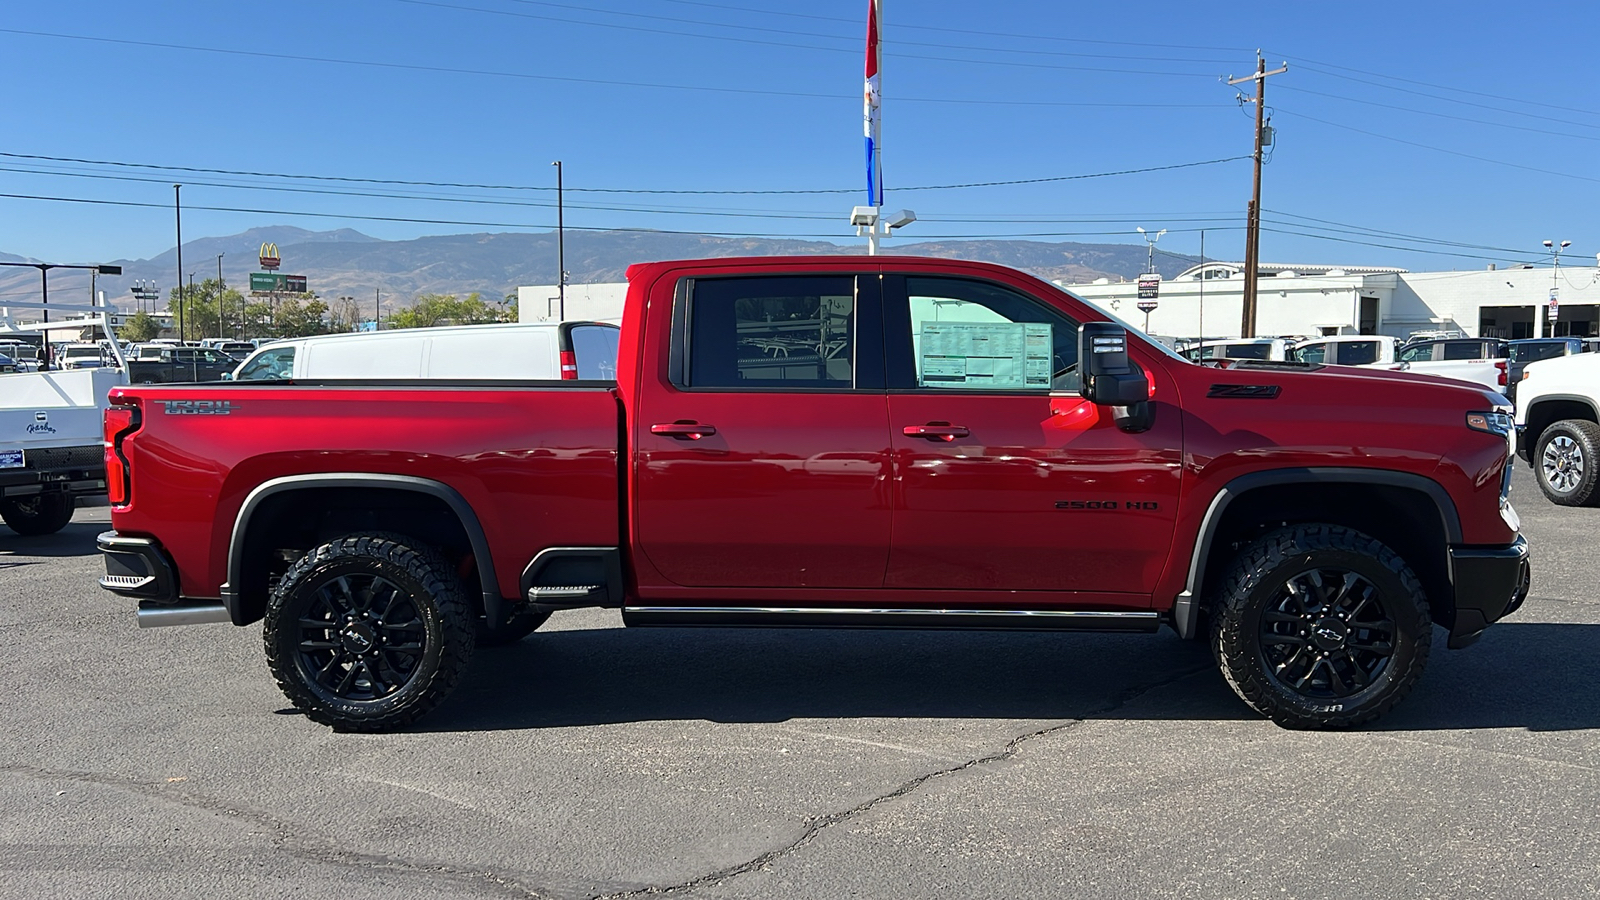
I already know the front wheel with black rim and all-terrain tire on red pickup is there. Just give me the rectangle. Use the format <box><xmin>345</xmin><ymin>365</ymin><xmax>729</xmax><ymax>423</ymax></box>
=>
<box><xmin>1210</xmin><ymin>525</ymin><xmax>1432</xmax><ymax>729</ymax></box>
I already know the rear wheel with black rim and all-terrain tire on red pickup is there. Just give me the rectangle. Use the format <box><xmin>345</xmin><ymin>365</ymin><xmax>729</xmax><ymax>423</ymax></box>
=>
<box><xmin>262</xmin><ymin>532</ymin><xmax>477</xmax><ymax>732</ymax></box>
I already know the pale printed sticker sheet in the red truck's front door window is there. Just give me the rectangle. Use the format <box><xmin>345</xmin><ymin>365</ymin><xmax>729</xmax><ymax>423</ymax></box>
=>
<box><xmin>917</xmin><ymin>322</ymin><xmax>1051</xmax><ymax>391</ymax></box>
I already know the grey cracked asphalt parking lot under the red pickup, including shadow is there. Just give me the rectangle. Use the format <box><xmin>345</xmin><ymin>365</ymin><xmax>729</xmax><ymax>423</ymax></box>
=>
<box><xmin>0</xmin><ymin>466</ymin><xmax>1600</xmax><ymax>900</ymax></box>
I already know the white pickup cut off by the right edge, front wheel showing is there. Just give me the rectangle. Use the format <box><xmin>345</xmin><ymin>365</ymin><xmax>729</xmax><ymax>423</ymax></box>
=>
<box><xmin>1517</xmin><ymin>352</ymin><xmax>1600</xmax><ymax>506</ymax></box>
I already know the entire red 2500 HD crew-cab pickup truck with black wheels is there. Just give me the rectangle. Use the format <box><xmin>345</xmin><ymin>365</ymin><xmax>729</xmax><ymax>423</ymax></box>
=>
<box><xmin>99</xmin><ymin>256</ymin><xmax>1530</xmax><ymax>730</ymax></box>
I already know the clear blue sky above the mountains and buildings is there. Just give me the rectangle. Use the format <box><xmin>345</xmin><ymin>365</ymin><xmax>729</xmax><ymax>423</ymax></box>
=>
<box><xmin>0</xmin><ymin>0</ymin><xmax>1600</xmax><ymax>271</ymax></box>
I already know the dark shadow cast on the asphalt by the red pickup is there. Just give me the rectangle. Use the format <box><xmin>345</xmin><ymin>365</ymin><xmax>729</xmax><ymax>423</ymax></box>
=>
<box><xmin>418</xmin><ymin>623</ymin><xmax>1600</xmax><ymax>732</ymax></box>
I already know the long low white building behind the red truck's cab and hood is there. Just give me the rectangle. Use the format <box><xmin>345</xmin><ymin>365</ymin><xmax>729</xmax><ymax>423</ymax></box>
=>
<box><xmin>517</xmin><ymin>263</ymin><xmax>1600</xmax><ymax>340</ymax></box>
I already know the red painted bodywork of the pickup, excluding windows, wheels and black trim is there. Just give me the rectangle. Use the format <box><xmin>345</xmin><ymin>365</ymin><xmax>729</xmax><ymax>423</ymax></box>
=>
<box><xmin>112</xmin><ymin>256</ymin><xmax>1515</xmax><ymax>610</ymax></box>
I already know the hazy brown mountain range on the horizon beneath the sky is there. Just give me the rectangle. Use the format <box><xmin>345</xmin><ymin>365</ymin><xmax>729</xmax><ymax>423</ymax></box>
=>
<box><xmin>0</xmin><ymin>226</ymin><xmax>1198</xmax><ymax>311</ymax></box>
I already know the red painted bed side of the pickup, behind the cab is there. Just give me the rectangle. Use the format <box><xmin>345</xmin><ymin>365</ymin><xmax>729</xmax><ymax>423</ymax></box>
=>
<box><xmin>112</xmin><ymin>383</ymin><xmax>619</xmax><ymax>597</ymax></box>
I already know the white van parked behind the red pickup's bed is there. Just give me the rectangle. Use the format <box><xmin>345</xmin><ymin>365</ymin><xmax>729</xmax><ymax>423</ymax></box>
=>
<box><xmin>232</xmin><ymin>322</ymin><xmax>621</xmax><ymax>381</ymax></box>
